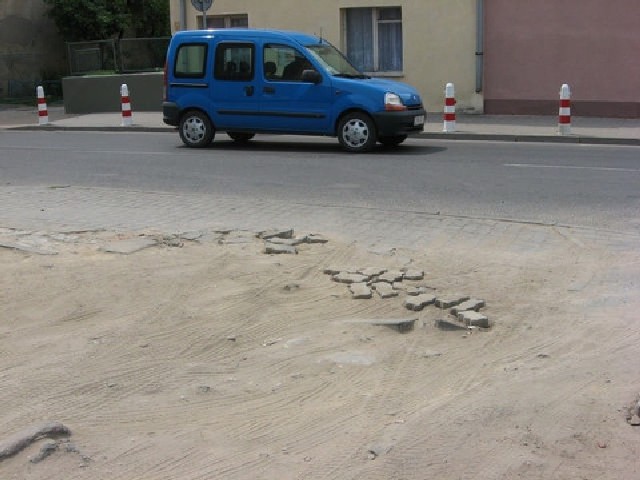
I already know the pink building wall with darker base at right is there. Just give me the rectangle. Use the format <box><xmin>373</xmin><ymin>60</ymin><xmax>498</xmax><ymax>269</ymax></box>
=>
<box><xmin>484</xmin><ymin>0</ymin><xmax>640</xmax><ymax>118</ymax></box>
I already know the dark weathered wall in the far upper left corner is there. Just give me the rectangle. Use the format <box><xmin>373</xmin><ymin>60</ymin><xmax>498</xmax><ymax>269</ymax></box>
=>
<box><xmin>0</xmin><ymin>0</ymin><xmax>67</xmax><ymax>96</ymax></box>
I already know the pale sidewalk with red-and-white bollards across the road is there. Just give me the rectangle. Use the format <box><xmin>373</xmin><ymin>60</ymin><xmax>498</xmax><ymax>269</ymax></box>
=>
<box><xmin>0</xmin><ymin>105</ymin><xmax>640</xmax><ymax>146</ymax></box>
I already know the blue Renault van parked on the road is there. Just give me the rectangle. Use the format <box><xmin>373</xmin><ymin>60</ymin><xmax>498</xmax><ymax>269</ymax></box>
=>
<box><xmin>162</xmin><ymin>29</ymin><xmax>426</xmax><ymax>152</ymax></box>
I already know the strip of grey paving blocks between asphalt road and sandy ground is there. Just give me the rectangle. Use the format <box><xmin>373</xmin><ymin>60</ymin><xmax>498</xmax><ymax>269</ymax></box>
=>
<box><xmin>0</xmin><ymin>186</ymin><xmax>640</xmax><ymax>253</ymax></box>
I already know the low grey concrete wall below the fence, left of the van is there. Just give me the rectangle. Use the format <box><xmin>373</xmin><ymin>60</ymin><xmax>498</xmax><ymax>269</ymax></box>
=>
<box><xmin>62</xmin><ymin>72</ymin><xmax>163</xmax><ymax>114</ymax></box>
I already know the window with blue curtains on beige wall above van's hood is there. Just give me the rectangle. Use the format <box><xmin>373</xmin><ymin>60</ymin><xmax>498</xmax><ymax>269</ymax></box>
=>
<box><xmin>343</xmin><ymin>7</ymin><xmax>402</xmax><ymax>72</ymax></box>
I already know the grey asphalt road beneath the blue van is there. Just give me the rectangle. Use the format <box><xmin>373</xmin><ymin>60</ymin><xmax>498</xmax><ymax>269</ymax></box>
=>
<box><xmin>0</xmin><ymin>131</ymin><xmax>640</xmax><ymax>233</ymax></box>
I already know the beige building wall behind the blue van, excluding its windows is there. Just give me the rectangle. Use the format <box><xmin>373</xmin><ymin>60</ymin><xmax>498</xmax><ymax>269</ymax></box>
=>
<box><xmin>171</xmin><ymin>0</ymin><xmax>482</xmax><ymax>112</ymax></box>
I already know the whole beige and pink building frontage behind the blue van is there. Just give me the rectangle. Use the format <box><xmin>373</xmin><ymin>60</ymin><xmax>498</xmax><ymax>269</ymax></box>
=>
<box><xmin>170</xmin><ymin>0</ymin><xmax>640</xmax><ymax>118</ymax></box>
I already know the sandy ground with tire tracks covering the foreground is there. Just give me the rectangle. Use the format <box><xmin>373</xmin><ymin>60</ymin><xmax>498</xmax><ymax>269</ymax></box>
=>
<box><xmin>0</xmin><ymin>227</ymin><xmax>640</xmax><ymax>480</ymax></box>
